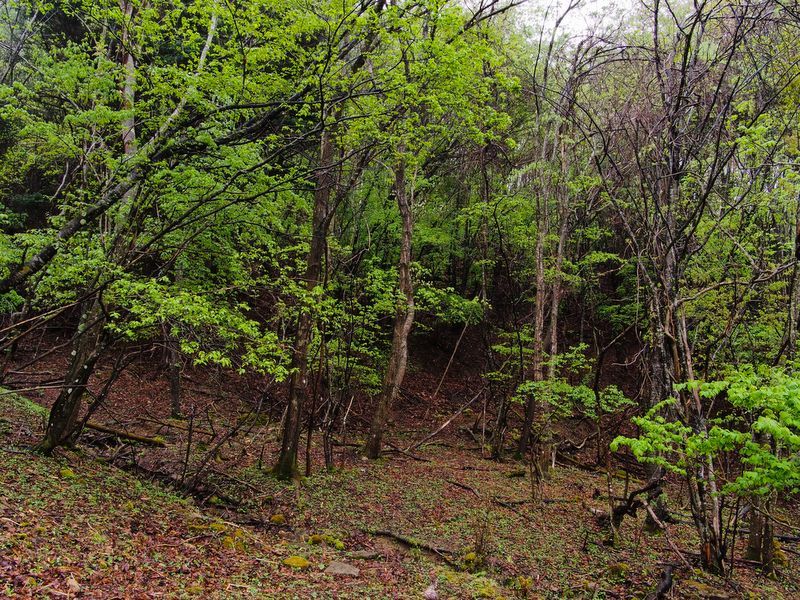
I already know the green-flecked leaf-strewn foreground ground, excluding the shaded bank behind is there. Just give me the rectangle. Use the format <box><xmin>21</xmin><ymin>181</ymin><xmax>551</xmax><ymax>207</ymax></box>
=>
<box><xmin>0</xmin><ymin>386</ymin><xmax>800</xmax><ymax>598</ymax></box>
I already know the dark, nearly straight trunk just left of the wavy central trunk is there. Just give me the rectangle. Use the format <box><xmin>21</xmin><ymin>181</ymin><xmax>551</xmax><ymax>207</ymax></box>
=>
<box><xmin>275</xmin><ymin>131</ymin><xmax>334</xmax><ymax>479</ymax></box>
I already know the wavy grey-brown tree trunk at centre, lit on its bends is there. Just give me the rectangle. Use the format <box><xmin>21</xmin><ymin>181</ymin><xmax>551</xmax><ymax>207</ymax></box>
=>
<box><xmin>365</xmin><ymin>164</ymin><xmax>414</xmax><ymax>459</ymax></box>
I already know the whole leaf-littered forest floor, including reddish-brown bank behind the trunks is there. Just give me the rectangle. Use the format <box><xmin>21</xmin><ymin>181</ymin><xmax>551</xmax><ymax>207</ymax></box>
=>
<box><xmin>0</xmin><ymin>336</ymin><xmax>800</xmax><ymax>599</ymax></box>
